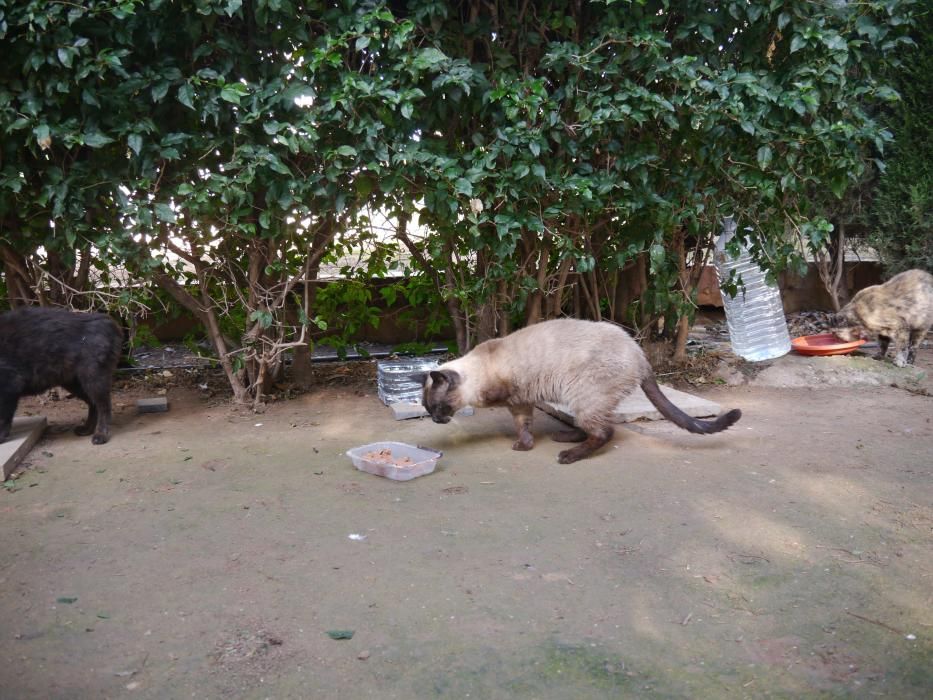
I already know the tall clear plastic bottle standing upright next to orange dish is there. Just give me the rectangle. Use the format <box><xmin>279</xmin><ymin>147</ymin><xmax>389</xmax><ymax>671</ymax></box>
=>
<box><xmin>713</xmin><ymin>216</ymin><xmax>790</xmax><ymax>362</ymax></box>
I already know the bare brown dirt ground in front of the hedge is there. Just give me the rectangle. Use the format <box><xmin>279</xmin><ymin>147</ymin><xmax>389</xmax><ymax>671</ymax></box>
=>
<box><xmin>0</xmin><ymin>350</ymin><xmax>933</xmax><ymax>699</ymax></box>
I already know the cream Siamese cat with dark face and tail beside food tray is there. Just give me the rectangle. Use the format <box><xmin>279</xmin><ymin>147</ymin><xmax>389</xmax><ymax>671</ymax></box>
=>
<box><xmin>417</xmin><ymin>318</ymin><xmax>742</xmax><ymax>464</ymax></box>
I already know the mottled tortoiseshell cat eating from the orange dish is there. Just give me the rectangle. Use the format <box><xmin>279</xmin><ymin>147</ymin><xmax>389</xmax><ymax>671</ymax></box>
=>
<box><xmin>830</xmin><ymin>270</ymin><xmax>933</xmax><ymax>367</ymax></box>
